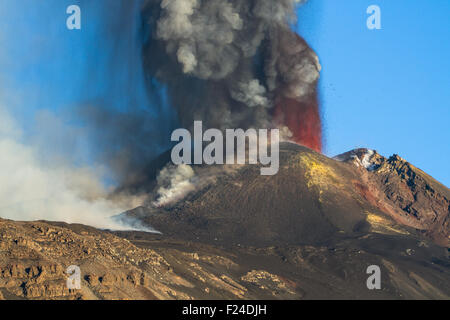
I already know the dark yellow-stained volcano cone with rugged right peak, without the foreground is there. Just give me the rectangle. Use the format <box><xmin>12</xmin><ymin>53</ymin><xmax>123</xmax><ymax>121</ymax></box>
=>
<box><xmin>122</xmin><ymin>143</ymin><xmax>450</xmax><ymax>246</ymax></box>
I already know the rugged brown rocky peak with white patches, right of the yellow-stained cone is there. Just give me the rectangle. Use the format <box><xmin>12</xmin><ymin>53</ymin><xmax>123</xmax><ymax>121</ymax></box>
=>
<box><xmin>336</xmin><ymin>149</ymin><xmax>450</xmax><ymax>247</ymax></box>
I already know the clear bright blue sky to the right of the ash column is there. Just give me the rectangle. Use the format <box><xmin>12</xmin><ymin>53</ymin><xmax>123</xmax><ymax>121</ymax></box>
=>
<box><xmin>297</xmin><ymin>0</ymin><xmax>450</xmax><ymax>186</ymax></box>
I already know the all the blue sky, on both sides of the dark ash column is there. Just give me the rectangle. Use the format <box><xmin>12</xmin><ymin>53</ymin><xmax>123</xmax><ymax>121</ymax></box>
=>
<box><xmin>0</xmin><ymin>0</ymin><xmax>450</xmax><ymax>186</ymax></box>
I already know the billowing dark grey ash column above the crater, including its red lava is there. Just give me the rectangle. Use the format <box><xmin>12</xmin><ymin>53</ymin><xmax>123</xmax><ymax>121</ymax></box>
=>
<box><xmin>143</xmin><ymin>0</ymin><xmax>322</xmax><ymax>151</ymax></box>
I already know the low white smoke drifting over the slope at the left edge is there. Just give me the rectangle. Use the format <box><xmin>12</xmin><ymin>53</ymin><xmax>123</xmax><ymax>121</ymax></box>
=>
<box><xmin>0</xmin><ymin>107</ymin><xmax>149</xmax><ymax>230</ymax></box>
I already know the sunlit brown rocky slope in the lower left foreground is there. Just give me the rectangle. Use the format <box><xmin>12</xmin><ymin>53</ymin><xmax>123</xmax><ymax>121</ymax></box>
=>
<box><xmin>0</xmin><ymin>220</ymin><xmax>299</xmax><ymax>299</ymax></box>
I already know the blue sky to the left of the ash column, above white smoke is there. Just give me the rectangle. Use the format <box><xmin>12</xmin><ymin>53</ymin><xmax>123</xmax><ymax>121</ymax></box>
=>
<box><xmin>0</xmin><ymin>0</ymin><xmax>148</xmax><ymax>119</ymax></box>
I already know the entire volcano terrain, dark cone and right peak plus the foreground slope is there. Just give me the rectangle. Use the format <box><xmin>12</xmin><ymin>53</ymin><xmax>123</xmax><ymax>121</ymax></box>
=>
<box><xmin>0</xmin><ymin>143</ymin><xmax>450</xmax><ymax>299</ymax></box>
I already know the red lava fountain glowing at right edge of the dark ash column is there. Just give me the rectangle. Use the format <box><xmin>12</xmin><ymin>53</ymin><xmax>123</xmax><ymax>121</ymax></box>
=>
<box><xmin>274</xmin><ymin>97</ymin><xmax>322</xmax><ymax>152</ymax></box>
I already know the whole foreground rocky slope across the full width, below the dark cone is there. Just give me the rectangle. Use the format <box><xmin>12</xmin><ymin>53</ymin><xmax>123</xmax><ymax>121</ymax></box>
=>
<box><xmin>0</xmin><ymin>220</ymin><xmax>450</xmax><ymax>299</ymax></box>
